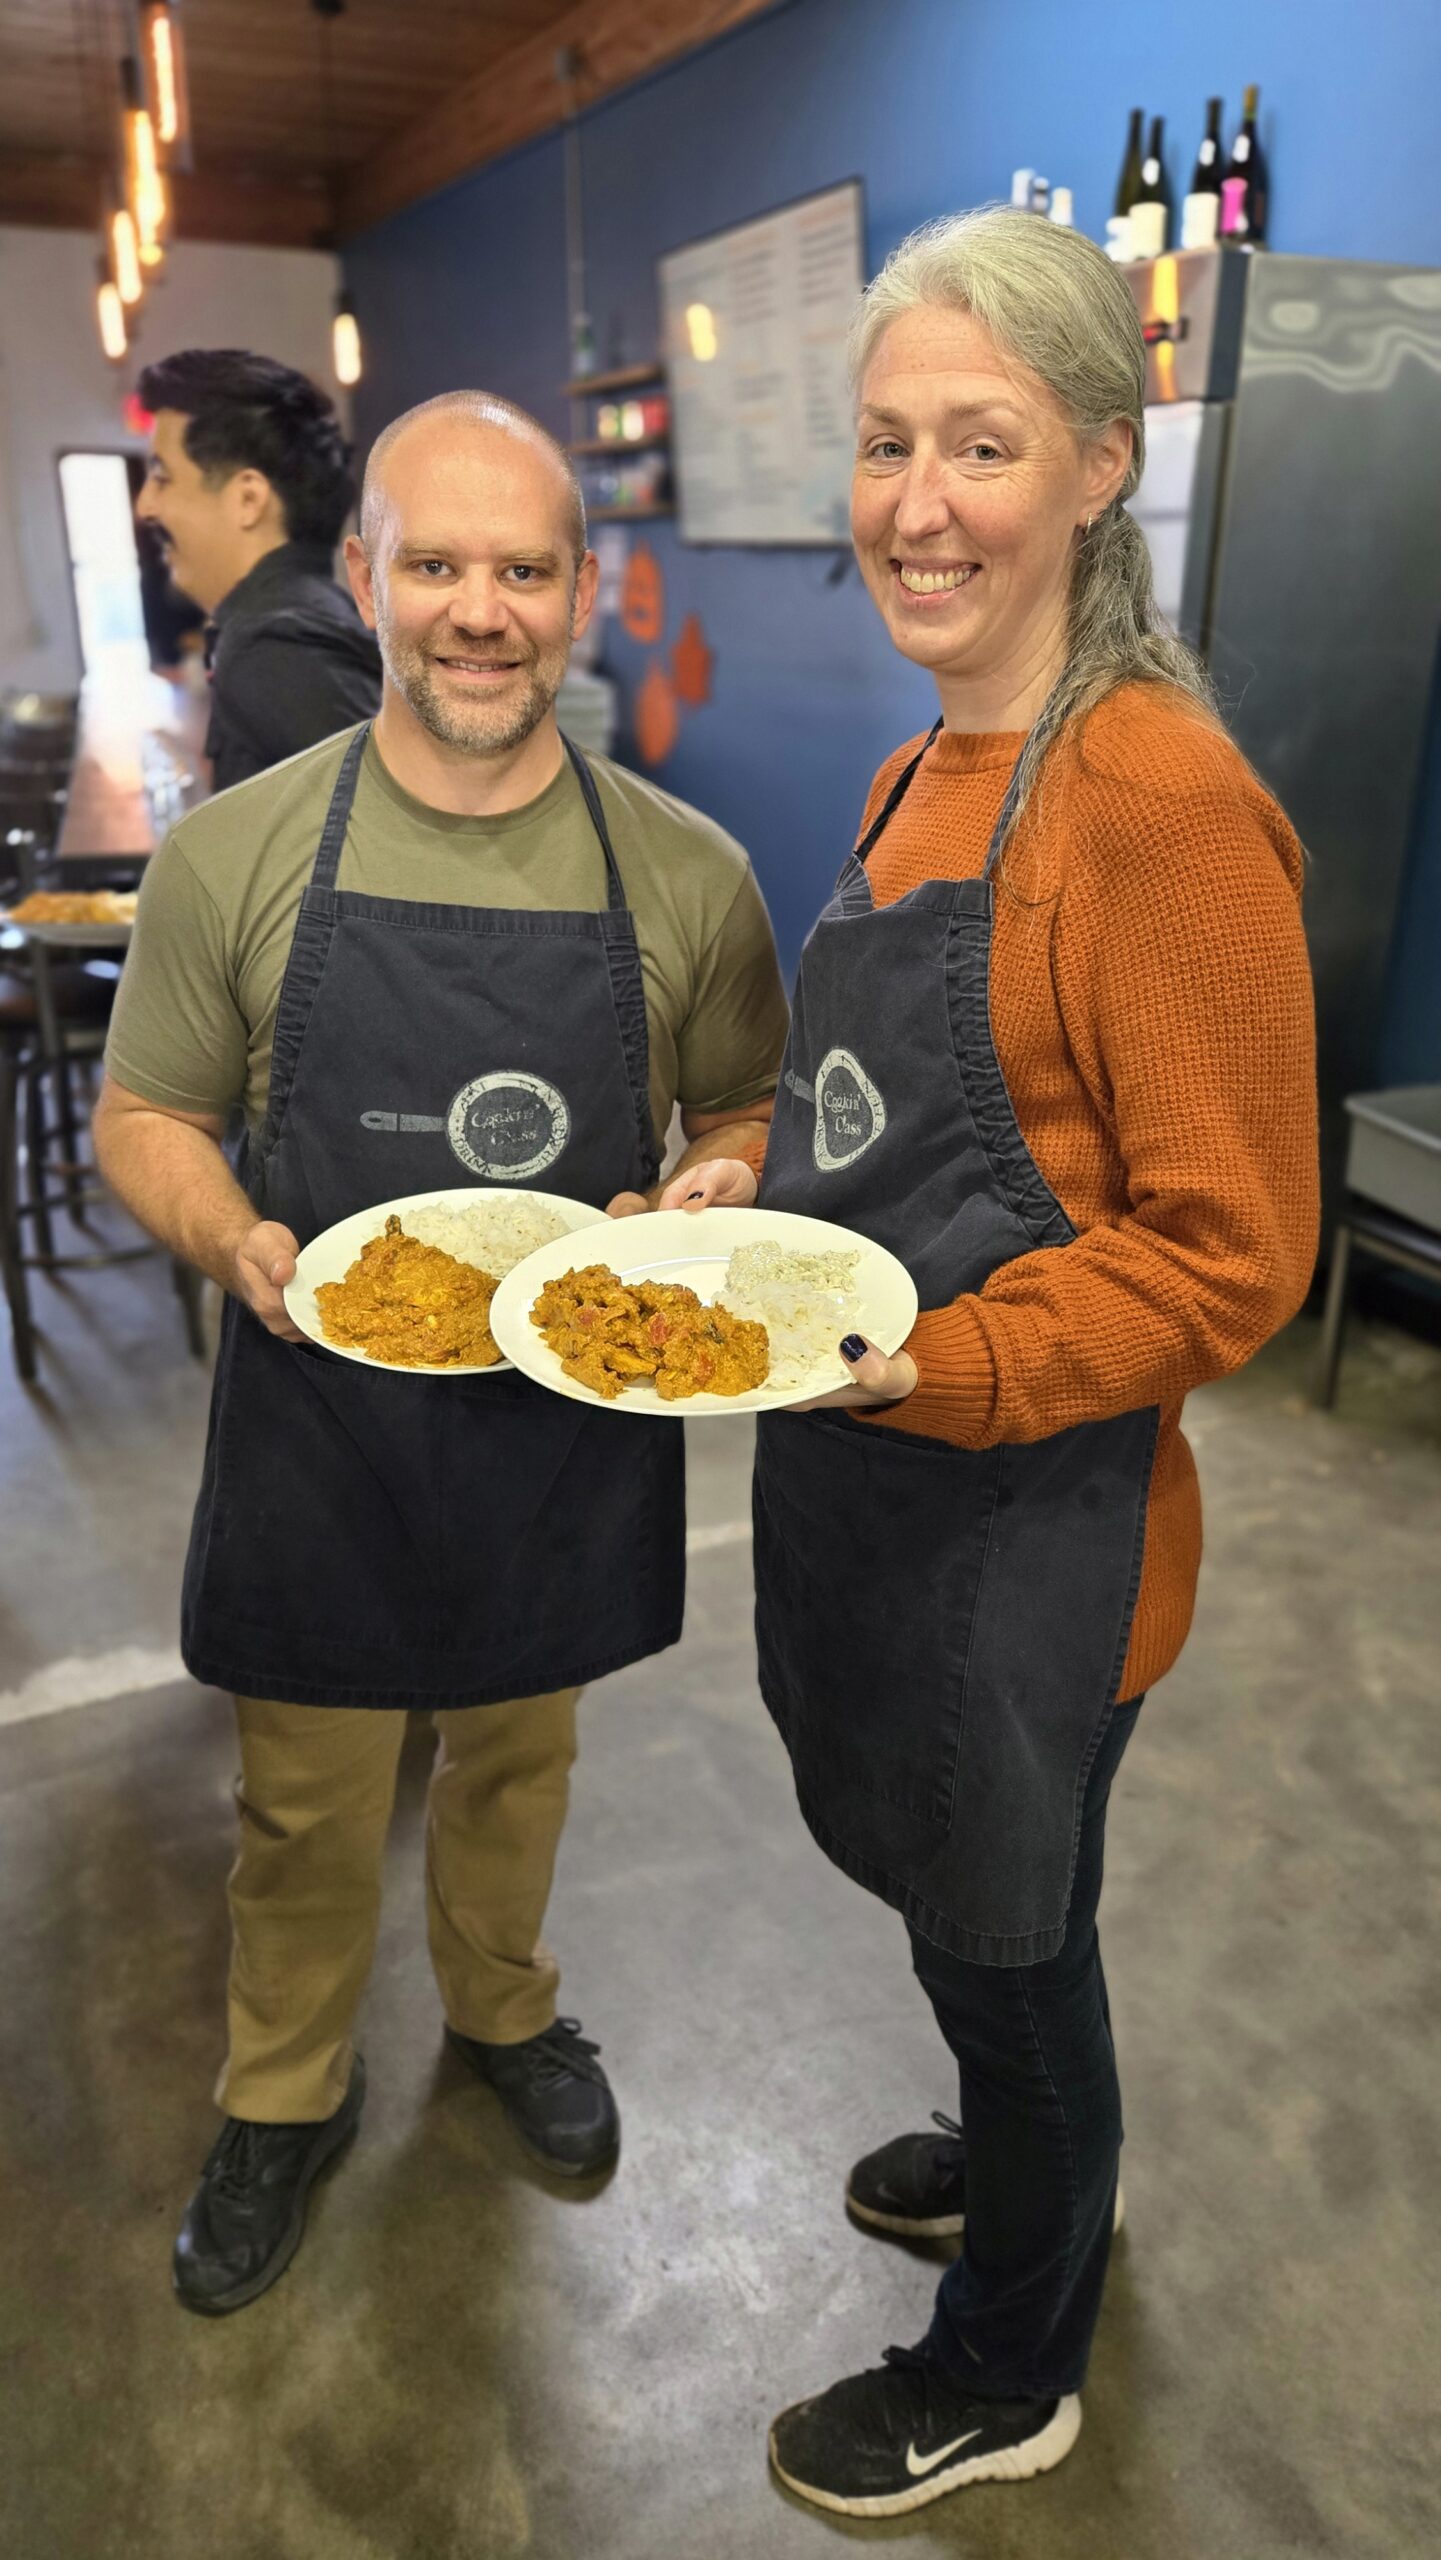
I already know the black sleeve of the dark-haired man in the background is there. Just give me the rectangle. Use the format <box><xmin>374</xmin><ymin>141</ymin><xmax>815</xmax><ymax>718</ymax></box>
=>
<box><xmin>210</xmin><ymin>622</ymin><xmax>381</xmax><ymax>791</ymax></box>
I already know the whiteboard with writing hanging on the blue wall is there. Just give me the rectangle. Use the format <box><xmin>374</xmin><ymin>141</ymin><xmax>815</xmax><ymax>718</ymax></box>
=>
<box><xmin>660</xmin><ymin>179</ymin><xmax>865</xmax><ymax>545</ymax></box>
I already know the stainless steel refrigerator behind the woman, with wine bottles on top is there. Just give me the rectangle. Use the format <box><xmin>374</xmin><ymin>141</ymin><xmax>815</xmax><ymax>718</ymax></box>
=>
<box><xmin>1126</xmin><ymin>248</ymin><xmax>1441</xmax><ymax>1224</ymax></box>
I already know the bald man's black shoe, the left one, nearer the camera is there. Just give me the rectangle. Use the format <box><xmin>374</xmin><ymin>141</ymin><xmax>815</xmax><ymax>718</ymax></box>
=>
<box><xmin>171</xmin><ymin>2053</ymin><xmax>366</xmax><ymax>2314</ymax></box>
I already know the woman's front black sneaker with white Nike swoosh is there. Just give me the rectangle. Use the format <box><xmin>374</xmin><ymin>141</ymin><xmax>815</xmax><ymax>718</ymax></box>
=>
<box><xmin>770</xmin><ymin>2345</ymin><xmax>1080</xmax><ymax>2516</ymax></box>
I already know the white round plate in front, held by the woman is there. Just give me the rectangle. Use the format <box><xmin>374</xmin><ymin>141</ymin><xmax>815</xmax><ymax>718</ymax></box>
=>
<box><xmin>491</xmin><ymin>1208</ymin><xmax>916</xmax><ymax>1421</ymax></box>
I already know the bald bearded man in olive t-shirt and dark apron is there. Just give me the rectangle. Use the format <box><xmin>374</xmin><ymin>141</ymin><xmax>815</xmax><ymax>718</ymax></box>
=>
<box><xmin>97</xmin><ymin>392</ymin><xmax>786</xmax><ymax>2314</ymax></box>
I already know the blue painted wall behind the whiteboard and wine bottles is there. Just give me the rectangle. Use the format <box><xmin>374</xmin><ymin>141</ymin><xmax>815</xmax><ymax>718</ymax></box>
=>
<box><xmin>346</xmin><ymin>0</ymin><xmax>1441</xmax><ymax>1059</ymax></box>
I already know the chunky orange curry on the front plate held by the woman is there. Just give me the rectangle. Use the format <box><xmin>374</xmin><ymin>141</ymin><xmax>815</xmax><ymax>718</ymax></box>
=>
<box><xmin>530</xmin><ymin>1262</ymin><xmax>770</xmax><ymax>1403</ymax></box>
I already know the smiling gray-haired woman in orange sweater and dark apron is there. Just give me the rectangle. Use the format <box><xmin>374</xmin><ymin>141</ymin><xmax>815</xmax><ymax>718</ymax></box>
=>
<box><xmin>676</xmin><ymin>210</ymin><xmax>1316</xmax><ymax>2516</ymax></box>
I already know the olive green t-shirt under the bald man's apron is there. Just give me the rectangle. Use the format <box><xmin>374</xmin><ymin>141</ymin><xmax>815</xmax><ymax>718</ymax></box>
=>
<box><xmin>105</xmin><ymin>730</ymin><xmax>786</xmax><ymax>1147</ymax></box>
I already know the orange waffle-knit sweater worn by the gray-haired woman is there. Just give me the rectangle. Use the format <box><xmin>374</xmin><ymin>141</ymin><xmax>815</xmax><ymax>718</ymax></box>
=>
<box><xmin>767</xmin><ymin>684</ymin><xmax>1318</xmax><ymax>1697</ymax></box>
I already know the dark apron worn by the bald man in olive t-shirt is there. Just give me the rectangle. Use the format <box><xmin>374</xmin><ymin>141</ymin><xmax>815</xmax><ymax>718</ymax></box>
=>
<box><xmin>182</xmin><ymin>730</ymin><xmax>686</xmax><ymax>1708</ymax></box>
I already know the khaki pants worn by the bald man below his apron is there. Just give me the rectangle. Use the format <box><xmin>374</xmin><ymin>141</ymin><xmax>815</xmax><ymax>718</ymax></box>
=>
<box><xmin>215</xmin><ymin>1690</ymin><xmax>581</xmax><ymax>2125</ymax></box>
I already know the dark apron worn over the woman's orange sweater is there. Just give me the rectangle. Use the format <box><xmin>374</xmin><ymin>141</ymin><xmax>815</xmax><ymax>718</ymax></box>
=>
<box><xmin>755</xmin><ymin>722</ymin><xmax>1157</xmax><ymax>1964</ymax></box>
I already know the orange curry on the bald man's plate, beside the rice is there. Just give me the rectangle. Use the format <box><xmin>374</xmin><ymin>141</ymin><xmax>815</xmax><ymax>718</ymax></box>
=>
<box><xmin>315</xmin><ymin>1219</ymin><xmax>502</xmax><ymax>1370</ymax></box>
